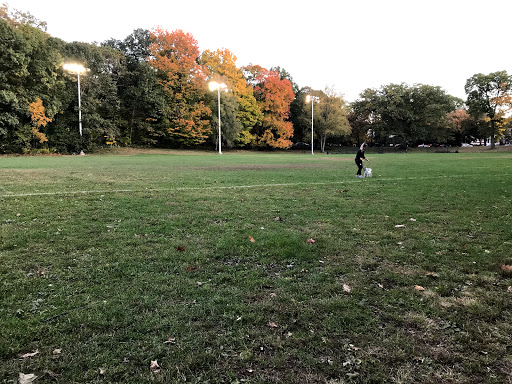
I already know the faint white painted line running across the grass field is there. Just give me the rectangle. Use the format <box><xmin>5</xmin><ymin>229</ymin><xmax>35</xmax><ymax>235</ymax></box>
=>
<box><xmin>0</xmin><ymin>175</ymin><xmax>463</xmax><ymax>198</ymax></box>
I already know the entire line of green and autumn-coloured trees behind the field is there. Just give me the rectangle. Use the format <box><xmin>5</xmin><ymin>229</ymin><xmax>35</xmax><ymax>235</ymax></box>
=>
<box><xmin>0</xmin><ymin>4</ymin><xmax>512</xmax><ymax>153</ymax></box>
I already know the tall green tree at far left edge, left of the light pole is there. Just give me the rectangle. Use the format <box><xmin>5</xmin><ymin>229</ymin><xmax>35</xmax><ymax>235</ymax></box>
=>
<box><xmin>0</xmin><ymin>7</ymin><xmax>64</xmax><ymax>152</ymax></box>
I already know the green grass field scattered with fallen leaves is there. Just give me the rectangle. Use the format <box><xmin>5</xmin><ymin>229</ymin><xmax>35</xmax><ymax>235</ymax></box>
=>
<box><xmin>0</xmin><ymin>151</ymin><xmax>512</xmax><ymax>384</ymax></box>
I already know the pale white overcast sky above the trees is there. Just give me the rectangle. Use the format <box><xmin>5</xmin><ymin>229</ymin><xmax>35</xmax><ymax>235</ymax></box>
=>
<box><xmin>7</xmin><ymin>0</ymin><xmax>512</xmax><ymax>102</ymax></box>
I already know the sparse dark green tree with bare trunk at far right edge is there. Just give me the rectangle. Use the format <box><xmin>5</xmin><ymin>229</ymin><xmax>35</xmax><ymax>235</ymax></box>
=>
<box><xmin>465</xmin><ymin>71</ymin><xmax>512</xmax><ymax>149</ymax></box>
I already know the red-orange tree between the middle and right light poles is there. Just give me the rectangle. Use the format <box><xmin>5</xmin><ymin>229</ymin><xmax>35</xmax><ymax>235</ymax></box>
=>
<box><xmin>243</xmin><ymin>64</ymin><xmax>294</xmax><ymax>148</ymax></box>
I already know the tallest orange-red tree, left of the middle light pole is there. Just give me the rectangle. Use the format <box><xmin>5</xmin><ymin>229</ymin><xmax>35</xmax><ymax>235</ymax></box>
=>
<box><xmin>149</xmin><ymin>28</ymin><xmax>211</xmax><ymax>145</ymax></box>
